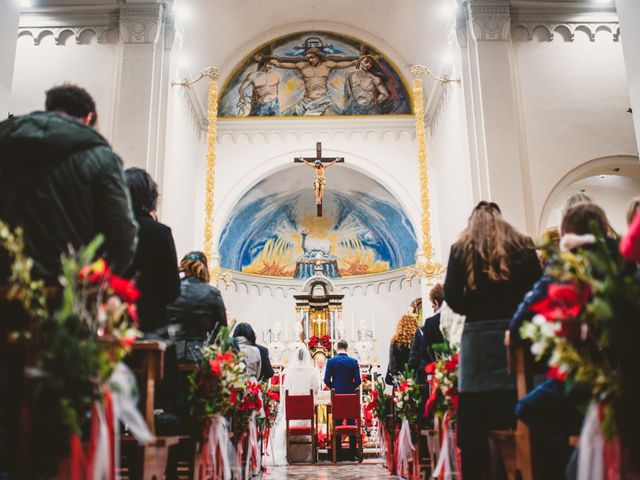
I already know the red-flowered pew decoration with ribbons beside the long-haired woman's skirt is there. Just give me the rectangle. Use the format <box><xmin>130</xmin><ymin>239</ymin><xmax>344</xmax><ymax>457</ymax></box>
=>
<box><xmin>424</xmin><ymin>344</ymin><xmax>461</xmax><ymax>478</ymax></box>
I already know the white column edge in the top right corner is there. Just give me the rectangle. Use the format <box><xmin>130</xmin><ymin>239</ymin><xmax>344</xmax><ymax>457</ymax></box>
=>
<box><xmin>616</xmin><ymin>0</ymin><xmax>640</xmax><ymax>154</ymax></box>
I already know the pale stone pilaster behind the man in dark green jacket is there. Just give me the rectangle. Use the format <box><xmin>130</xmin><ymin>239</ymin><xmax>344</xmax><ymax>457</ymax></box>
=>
<box><xmin>113</xmin><ymin>2</ymin><xmax>166</xmax><ymax>177</ymax></box>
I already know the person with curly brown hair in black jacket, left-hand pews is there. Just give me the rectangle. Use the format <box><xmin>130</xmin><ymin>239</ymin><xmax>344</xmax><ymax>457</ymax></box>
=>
<box><xmin>167</xmin><ymin>252</ymin><xmax>227</xmax><ymax>363</ymax></box>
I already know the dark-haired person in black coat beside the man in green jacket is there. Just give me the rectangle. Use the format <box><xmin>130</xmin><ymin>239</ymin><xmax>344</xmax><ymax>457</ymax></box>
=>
<box><xmin>125</xmin><ymin>167</ymin><xmax>180</xmax><ymax>333</ymax></box>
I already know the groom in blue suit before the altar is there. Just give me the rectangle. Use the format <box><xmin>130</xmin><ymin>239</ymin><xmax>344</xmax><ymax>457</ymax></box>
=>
<box><xmin>324</xmin><ymin>340</ymin><xmax>362</xmax><ymax>459</ymax></box>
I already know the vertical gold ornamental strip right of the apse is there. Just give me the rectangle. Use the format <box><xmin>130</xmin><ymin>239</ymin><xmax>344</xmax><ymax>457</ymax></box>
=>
<box><xmin>407</xmin><ymin>65</ymin><xmax>446</xmax><ymax>283</ymax></box>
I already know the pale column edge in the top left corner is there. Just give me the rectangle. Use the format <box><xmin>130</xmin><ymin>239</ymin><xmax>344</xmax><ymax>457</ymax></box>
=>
<box><xmin>0</xmin><ymin>0</ymin><xmax>20</xmax><ymax>121</ymax></box>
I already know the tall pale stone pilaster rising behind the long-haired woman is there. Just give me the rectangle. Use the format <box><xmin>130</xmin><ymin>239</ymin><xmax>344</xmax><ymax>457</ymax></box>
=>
<box><xmin>457</xmin><ymin>0</ymin><xmax>536</xmax><ymax>234</ymax></box>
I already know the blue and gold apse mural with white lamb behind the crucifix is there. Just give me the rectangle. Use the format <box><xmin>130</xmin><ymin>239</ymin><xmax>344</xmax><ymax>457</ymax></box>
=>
<box><xmin>219</xmin><ymin>165</ymin><xmax>418</xmax><ymax>278</ymax></box>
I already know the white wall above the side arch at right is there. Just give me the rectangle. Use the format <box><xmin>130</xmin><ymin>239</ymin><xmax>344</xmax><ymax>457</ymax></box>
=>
<box><xmin>513</xmin><ymin>29</ymin><xmax>637</xmax><ymax>233</ymax></box>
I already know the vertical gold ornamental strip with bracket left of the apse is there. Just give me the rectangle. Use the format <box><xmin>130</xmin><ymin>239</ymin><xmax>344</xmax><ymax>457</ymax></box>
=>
<box><xmin>171</xmin><ymin>67</ymin><xmax>221</xmax><ymax>278</ymax></box>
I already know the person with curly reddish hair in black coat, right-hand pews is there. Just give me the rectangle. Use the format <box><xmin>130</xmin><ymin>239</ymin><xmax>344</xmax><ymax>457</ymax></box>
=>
<box><xmin>409</xmin><ymin>283</ymin><xmax>444</xmax><ymax>385</ymax></box>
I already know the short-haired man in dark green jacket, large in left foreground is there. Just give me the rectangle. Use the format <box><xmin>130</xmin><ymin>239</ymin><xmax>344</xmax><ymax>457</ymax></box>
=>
<box><xmin>0</xmin><ymin>84</ymin><xmax>138</xmax><ymax>478</ymax></box>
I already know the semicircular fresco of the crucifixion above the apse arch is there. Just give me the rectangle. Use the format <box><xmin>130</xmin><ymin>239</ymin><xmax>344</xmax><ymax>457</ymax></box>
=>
<box><xmin>218</xmin><ymin>32</ymin><xmax>411</xmax><ymax>117</ymax></box>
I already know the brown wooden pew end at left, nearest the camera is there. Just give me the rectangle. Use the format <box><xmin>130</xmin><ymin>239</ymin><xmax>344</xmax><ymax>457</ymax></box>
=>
<box><xmin>121</xmin><ymin>340</ymin><xmax>181</xmax><ymax>480</ymax></box>
